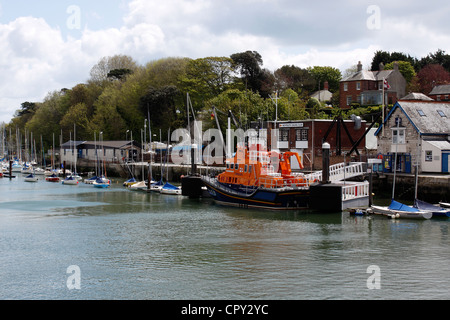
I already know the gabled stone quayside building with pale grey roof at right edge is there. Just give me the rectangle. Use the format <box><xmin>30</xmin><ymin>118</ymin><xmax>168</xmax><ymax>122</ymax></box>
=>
<box><xmin>375</xmin><ymin>100</ymin><xmax>450</xmax><ymax>173</ymax></box>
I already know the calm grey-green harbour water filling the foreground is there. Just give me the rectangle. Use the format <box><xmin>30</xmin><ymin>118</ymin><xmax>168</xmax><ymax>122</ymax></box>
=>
<box><xmin>0</xmin><ymin>174</ymin><xmax>450</xmax><ymax>300</ymax></box>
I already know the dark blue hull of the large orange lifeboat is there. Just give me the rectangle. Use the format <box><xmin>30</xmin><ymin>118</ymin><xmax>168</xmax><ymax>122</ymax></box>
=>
<box><xmin>203</xmin><ymin>179</ymin><xmax>310</xmax><ymax>210</ymax></box>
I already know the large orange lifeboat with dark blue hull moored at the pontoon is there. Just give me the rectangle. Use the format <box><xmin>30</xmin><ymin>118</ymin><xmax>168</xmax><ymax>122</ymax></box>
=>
<box><xmin>202</xmin><ymin>146</ymin><xmax>316</xmax><ymax>210</ymax></box>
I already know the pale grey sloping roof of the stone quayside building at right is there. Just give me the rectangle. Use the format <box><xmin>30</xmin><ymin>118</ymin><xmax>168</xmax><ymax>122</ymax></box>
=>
<box><xmin>394</xmin><ymin>101</ymin><xmax>450</xmax><ymax>134</ymax></box>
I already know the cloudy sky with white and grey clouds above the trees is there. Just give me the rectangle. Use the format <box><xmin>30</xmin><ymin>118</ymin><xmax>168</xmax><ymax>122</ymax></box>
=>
<box><xmin>0</xmin><ymin>0</ymin><xmax>450</xmax><ymax>123</ymax></box>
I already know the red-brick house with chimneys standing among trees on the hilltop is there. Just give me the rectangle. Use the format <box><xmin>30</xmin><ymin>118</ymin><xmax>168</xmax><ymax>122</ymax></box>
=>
<box><xmin>339</xmin><ymin>62</ymin><xmax>406</xmax><ymax>109</ymax></box>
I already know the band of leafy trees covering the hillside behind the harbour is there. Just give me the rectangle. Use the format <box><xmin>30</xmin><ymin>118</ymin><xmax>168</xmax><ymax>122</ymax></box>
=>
<box><xmin>8</xmin><ymin>50</ymin><xmax>450</xmax><ymax>147</ymax></box>
